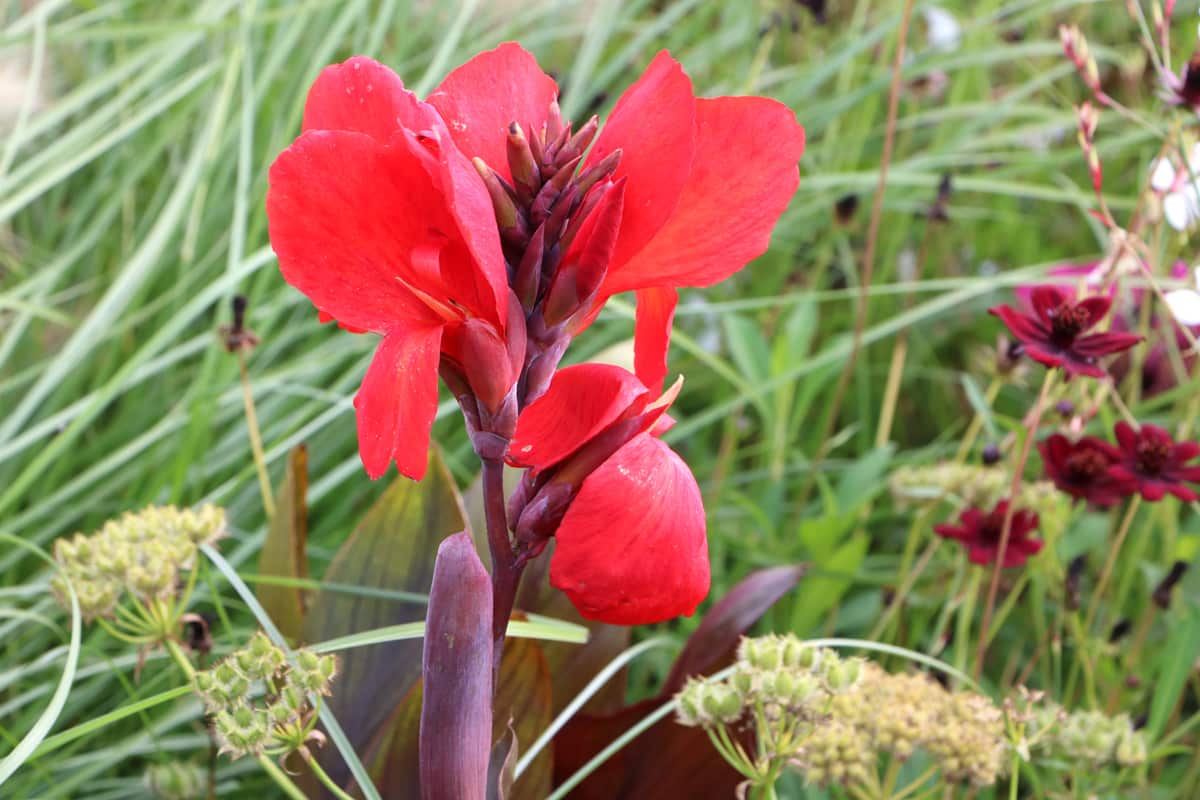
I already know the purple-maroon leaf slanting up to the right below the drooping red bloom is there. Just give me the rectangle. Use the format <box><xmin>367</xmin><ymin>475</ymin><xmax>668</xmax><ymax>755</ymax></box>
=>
<box><xmin>659</xmin><ymin>564</ymin><xmax>806</xmax><ymax>697</ymax></box>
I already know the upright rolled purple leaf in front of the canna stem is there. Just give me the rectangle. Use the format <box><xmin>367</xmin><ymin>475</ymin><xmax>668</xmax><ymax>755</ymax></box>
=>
<box><xmin>420</xmin><ymin>533</ymin><xmax>492</xmax><ymax>800</ymax></box>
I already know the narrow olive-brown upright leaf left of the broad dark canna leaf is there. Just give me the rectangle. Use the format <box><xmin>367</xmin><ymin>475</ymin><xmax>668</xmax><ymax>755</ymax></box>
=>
<box><xmin>254</xmin><ymin>445</ymin><xmax>308</xmax><ymax>642</ymax></box>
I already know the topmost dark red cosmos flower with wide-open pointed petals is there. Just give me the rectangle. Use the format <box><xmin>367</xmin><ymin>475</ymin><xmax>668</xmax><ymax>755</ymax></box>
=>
<box><xmin>988</xmin><ymin>287</ymin><xmax>1141</xmax><ymax>378</ymax></box>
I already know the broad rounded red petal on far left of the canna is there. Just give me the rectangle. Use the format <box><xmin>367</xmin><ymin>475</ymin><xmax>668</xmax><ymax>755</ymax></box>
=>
<box><xmin>266</xmin><ymin>131</ymin><xmax>452</xmax><ymax>332</ymax></box>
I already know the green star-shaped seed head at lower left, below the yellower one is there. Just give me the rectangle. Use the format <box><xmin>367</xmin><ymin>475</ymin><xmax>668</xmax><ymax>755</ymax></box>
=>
<box><xmin>193</xmin><ymin>633</ymin><xmax>337</xmax><ymax>758</ymax></box>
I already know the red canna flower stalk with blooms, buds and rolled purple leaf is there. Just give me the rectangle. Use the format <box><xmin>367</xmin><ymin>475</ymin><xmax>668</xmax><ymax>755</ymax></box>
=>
<box><xmin>266</xmin><ymin>38</ymin><xmax>804</xmax><ymax>798</ymax></box>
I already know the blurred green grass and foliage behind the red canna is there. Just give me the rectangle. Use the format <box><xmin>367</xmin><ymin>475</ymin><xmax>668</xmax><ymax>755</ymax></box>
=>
<box><xmin>0</xmin><ymin>0</ymin><xmax>1198</xmax><ymax>798</ymax></box>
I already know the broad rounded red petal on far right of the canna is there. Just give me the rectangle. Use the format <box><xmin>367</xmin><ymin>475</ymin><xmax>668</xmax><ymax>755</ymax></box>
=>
<box><xmin>605</xmin><ymin>97</ymin><xmax>804</xmax><ymax>293</ymax></box>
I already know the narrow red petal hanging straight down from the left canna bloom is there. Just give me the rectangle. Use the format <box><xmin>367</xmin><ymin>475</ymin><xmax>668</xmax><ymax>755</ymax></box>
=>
<box><xmin>354</xmin><ymin>325</ymin><xmax>451</xmax><ymax>481</ymax></box>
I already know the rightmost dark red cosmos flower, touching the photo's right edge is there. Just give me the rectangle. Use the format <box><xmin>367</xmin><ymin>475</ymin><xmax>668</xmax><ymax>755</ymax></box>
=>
<box><xmin>1109</xmin><ymin>421</ymin><xmax>1200</xmax><ymax>503</ymax></box>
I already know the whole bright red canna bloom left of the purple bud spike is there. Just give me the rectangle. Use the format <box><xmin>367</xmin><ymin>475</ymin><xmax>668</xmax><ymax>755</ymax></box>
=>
<box><xmin>266</xmin><ymin>58</ymin><xmax>528</xmax><ymax>480</ymax></box>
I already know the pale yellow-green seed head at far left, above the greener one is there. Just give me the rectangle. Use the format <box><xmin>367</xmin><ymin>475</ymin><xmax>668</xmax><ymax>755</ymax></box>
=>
<box><xmin>53</xmin><ymin>505</ymin><xmax>226</xmax><ymax>620</ymax></box>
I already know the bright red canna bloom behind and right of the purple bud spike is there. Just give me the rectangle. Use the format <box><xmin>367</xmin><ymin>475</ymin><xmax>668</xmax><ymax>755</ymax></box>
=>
<box><xmin>430</xmin><ymin>44</ymin><xmax>804</xmax><ymax>386</ymax></box>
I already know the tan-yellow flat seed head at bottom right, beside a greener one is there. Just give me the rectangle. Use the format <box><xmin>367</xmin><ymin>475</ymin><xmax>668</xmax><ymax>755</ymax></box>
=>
<box><xmin>798</xmin><ymin>663</ymin><xmax>1009</xmax><ymax>786</ymax></box>
